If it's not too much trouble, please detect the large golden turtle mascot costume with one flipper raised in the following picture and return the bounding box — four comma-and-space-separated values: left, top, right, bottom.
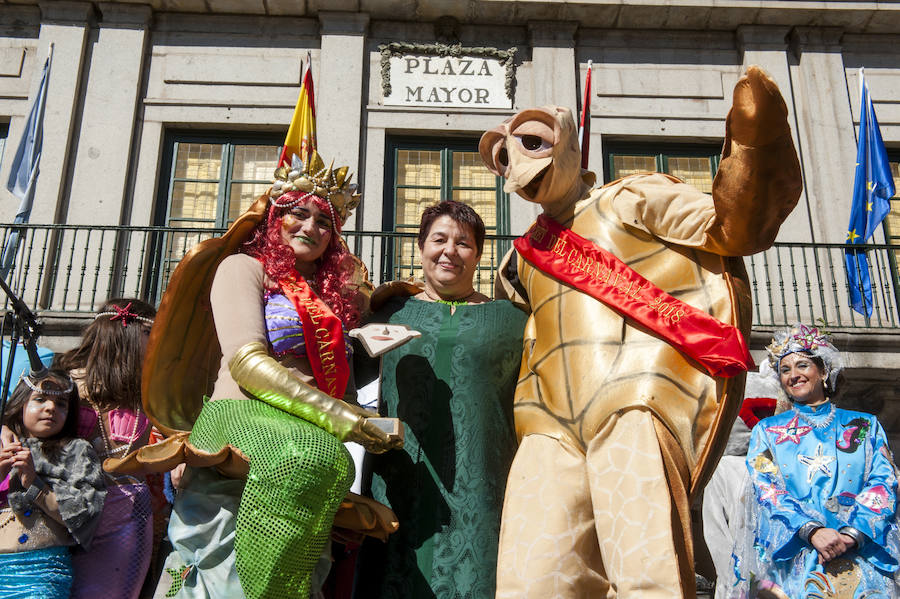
480, 67, 801, 599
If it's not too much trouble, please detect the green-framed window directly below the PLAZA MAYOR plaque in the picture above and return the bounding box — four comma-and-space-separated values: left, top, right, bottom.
385, 139, 509, 295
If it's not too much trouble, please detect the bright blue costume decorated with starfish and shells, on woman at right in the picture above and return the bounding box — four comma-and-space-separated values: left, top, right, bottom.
731, 402, 900, 599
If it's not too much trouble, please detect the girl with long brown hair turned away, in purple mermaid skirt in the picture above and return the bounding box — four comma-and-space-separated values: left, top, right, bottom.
56, 298, 156, 599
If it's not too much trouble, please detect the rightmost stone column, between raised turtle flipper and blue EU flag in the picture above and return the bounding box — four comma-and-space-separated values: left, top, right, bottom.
791, 27, 856, 243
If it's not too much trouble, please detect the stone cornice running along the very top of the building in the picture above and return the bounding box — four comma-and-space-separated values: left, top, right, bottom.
3, 0, 900, 33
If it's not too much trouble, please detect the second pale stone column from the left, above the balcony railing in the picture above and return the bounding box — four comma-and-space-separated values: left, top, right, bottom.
66, 2, 152, 225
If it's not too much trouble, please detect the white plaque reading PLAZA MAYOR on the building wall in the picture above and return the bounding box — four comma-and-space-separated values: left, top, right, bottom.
383, 55, 512, 108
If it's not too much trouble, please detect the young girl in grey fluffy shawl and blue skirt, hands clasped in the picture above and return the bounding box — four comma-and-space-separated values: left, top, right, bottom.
0, 370, 106, 599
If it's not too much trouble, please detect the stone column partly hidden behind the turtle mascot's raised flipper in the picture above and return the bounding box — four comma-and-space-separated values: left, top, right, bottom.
736, 25, 815, 241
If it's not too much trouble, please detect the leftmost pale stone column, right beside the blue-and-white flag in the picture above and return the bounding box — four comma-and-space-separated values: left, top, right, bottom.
30, 2, 93, 223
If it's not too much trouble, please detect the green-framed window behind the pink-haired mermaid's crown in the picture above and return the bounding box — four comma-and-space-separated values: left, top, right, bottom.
158, 133, 284, 288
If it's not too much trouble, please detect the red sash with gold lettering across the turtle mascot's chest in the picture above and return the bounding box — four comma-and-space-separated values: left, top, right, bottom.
515, 214, 755, 377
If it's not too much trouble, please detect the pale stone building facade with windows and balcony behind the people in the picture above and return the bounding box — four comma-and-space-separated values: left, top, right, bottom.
0, 0, 900, 432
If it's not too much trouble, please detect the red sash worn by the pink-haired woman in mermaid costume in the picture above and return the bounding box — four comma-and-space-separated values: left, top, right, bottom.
280, 273, 350, 399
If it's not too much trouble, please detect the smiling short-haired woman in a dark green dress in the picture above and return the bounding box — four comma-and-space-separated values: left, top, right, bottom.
355, 201, 526, 599
